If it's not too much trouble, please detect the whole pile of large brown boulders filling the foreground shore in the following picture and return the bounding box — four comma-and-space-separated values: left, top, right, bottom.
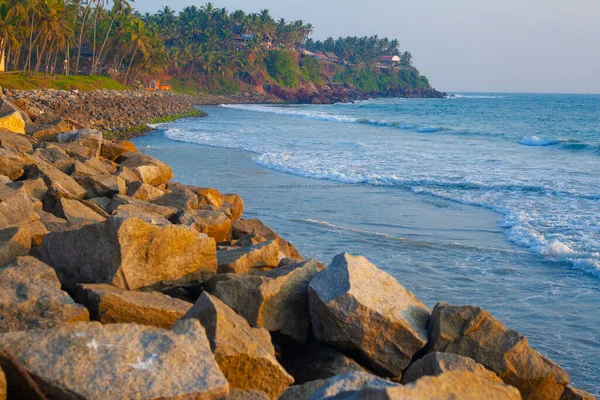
0, 97, 594, 400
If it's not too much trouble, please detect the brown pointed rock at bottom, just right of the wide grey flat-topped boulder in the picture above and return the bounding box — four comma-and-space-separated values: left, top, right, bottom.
183, 292, 294, 399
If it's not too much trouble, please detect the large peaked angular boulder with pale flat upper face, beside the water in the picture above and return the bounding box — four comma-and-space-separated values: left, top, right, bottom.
308, 253, 429, 378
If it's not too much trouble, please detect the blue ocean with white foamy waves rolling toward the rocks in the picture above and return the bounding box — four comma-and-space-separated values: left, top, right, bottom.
136, 93, 600, 395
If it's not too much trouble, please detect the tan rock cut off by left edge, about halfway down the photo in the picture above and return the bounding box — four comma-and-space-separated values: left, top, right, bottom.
0, 186, 40, 229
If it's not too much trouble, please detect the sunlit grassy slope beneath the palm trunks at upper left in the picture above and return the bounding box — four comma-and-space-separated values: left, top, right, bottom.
0, 72, 125, 92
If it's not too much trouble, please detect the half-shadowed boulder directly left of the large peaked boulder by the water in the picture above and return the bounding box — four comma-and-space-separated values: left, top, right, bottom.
207, 260, 325, 343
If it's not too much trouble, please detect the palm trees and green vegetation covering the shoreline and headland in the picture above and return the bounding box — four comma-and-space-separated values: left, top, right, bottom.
0, 0, 428, 94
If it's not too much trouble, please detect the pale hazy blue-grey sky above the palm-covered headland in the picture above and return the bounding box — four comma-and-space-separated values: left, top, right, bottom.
135, 0, 600, 93
